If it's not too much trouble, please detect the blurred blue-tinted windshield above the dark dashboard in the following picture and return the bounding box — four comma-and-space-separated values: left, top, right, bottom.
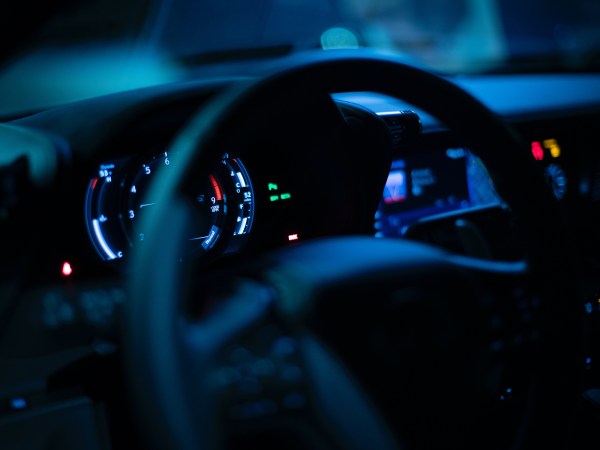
0, 0, 600, 115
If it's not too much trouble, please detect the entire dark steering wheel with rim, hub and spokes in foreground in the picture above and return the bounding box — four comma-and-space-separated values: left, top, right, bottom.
123, 51, 580, 449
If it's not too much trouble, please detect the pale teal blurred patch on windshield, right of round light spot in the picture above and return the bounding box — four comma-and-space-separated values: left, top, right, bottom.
341, 0, 507, 72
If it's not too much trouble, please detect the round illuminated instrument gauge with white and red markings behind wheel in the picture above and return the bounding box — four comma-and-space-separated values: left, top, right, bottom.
87, 152, 254, 260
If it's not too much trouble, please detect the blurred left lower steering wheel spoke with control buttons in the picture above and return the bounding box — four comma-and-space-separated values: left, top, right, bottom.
171, 279, 396, 450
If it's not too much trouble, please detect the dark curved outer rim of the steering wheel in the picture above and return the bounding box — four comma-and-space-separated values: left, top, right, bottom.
124, 51, 576, 448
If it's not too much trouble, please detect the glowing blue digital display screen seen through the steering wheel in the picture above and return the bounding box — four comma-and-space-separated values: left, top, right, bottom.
375, 148, 497, 236
